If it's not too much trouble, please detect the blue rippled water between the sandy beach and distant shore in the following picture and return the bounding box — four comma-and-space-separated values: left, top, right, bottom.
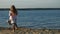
0, 10, 60, 29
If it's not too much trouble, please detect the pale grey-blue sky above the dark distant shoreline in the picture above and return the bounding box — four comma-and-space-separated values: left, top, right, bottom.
0, 0, 60, 8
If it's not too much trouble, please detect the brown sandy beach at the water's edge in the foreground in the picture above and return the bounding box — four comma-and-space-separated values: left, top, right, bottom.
0, 27, 60, 34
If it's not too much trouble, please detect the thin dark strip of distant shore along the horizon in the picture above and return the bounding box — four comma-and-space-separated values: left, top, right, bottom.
0, 8, 60, 10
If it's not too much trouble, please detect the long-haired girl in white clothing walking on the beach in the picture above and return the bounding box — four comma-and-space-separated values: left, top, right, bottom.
8, 5, 17, 32
